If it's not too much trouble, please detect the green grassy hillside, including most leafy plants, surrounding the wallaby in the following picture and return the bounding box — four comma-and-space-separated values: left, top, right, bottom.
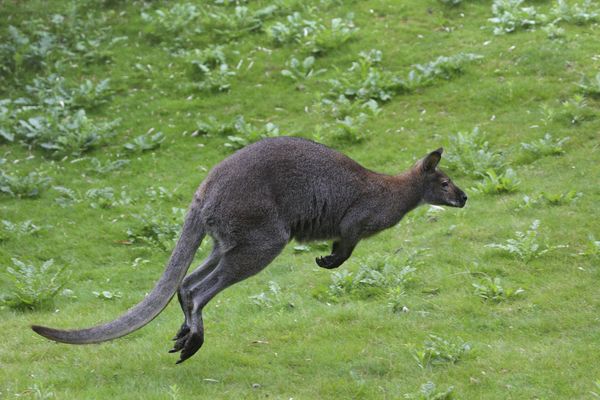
0, 0, 600, 399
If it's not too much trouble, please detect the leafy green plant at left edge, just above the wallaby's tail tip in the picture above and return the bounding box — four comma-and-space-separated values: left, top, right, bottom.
1, 258, 65, 310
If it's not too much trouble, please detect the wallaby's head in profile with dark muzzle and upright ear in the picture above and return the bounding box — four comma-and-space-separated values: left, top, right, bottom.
413, 147, 467, 208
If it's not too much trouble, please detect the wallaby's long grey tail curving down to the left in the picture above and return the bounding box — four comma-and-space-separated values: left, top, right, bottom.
31, 204, 206, 344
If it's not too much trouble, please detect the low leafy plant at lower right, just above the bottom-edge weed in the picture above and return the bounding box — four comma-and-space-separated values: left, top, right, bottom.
411, 335, 471, 369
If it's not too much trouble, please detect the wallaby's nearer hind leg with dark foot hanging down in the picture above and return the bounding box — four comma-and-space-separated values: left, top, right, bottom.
171, 237, 289, 363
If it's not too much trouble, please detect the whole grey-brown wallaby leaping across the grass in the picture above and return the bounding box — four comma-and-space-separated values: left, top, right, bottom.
32, 137, 467, 364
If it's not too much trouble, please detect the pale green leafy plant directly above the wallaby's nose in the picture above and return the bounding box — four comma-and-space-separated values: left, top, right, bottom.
444, 127, 504, 177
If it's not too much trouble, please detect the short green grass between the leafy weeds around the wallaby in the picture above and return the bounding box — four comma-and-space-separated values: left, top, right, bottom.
0, 0, 600, 399
